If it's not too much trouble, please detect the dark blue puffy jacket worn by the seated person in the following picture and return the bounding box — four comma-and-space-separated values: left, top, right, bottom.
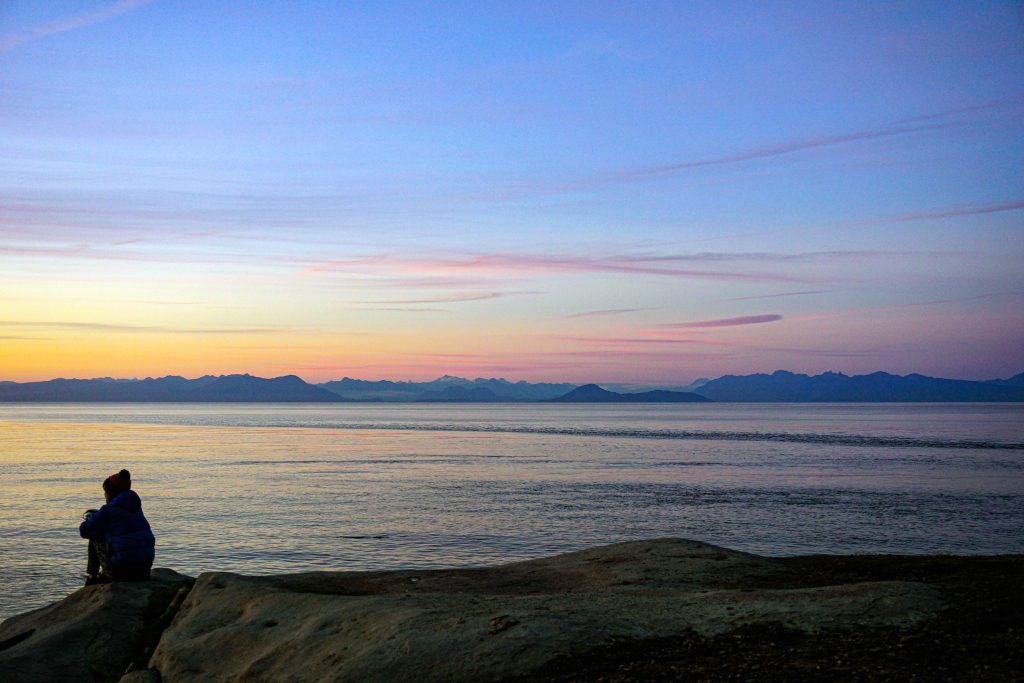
78, 490, 157, 565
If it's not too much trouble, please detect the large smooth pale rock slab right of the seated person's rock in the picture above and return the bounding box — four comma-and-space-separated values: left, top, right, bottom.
150, 539, 941, 683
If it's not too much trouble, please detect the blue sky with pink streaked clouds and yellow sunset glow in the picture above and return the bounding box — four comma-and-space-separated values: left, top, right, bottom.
0, 0, 1024, 386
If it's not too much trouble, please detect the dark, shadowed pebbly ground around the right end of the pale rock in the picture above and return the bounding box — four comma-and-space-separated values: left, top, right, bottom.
509, 555, 1024, 683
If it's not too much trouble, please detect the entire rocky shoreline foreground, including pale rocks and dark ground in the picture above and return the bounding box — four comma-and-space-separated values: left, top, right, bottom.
0, 539, 1024, 683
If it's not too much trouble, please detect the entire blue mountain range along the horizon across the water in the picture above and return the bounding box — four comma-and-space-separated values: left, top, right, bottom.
0, 371, 1024, 403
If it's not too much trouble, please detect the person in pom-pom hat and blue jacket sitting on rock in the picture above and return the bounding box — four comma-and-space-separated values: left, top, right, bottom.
78, 470, 157, 586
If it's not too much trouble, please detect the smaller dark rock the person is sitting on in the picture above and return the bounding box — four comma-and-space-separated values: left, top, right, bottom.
0, 569, 193, 683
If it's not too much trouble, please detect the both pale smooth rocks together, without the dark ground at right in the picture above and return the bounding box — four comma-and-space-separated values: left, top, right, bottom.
0, 539, 944, 683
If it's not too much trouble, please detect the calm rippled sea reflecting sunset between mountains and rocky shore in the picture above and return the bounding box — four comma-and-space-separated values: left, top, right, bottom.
0, 403, 1024, 618
